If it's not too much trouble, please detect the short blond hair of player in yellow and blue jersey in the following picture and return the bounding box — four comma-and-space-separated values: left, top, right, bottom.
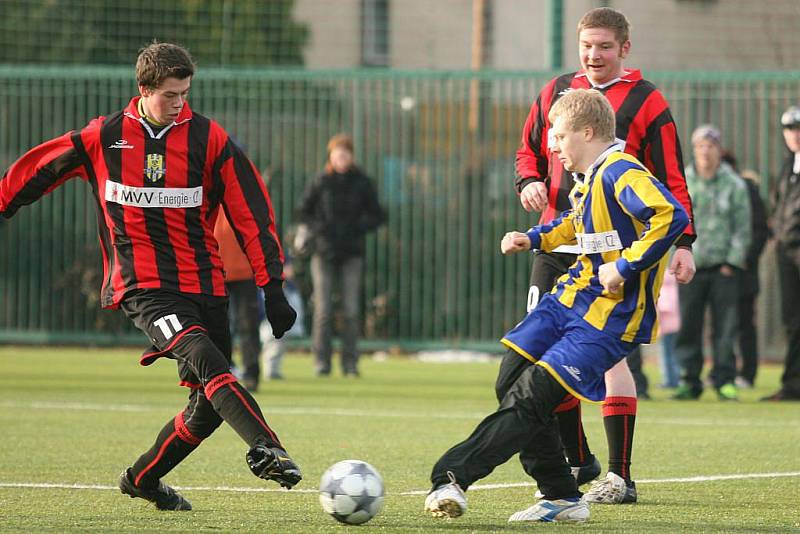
547, 89, 616, 141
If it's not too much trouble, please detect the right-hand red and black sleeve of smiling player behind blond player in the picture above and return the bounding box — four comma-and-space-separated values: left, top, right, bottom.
642, 91, 696, 245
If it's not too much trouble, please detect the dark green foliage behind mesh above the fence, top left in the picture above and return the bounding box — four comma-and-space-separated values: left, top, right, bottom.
0, 0, 308, 67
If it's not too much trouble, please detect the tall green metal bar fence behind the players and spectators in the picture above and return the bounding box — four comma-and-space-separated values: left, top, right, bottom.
0, 66, 800, 347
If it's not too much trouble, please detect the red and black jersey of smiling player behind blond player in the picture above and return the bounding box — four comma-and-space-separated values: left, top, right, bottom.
515, 70, 695, 245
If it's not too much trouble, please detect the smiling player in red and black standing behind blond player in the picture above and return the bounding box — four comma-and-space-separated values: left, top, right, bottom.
507, 8, 695, 502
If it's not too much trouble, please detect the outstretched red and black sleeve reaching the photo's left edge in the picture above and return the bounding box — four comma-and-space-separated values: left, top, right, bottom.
0, 132, 86, 217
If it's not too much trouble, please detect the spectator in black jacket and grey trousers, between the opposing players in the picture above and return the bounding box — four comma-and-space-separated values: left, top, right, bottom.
299, 134, 386, 376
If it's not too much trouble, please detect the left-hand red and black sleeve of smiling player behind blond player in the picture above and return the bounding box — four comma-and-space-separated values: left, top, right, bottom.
514, 79, 556, 193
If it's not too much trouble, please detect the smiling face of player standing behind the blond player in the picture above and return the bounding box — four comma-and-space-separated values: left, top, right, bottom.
578, 28, 631, 85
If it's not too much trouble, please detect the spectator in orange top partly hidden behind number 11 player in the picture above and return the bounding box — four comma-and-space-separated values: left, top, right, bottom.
214, 214, 260, 392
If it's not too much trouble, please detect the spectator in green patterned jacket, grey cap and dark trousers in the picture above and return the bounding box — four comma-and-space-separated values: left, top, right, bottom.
673, 125, 751, 400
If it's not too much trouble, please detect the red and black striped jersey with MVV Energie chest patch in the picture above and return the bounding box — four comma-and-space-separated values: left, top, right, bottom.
0, 97, 283, 308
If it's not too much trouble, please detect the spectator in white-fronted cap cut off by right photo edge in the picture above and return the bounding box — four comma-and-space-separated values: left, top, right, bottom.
762, 106, 800, 401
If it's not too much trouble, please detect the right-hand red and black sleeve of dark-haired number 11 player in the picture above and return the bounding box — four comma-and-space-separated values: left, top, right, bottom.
211, 127, 284, 286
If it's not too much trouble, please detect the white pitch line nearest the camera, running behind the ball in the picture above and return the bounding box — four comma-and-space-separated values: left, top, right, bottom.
0, 471, 800, 495
